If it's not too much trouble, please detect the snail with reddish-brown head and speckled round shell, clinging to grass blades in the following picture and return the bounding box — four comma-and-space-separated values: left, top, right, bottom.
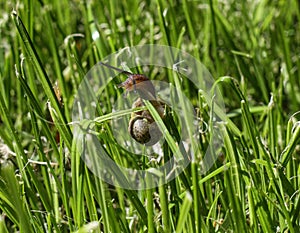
100, 62, 165, 146
